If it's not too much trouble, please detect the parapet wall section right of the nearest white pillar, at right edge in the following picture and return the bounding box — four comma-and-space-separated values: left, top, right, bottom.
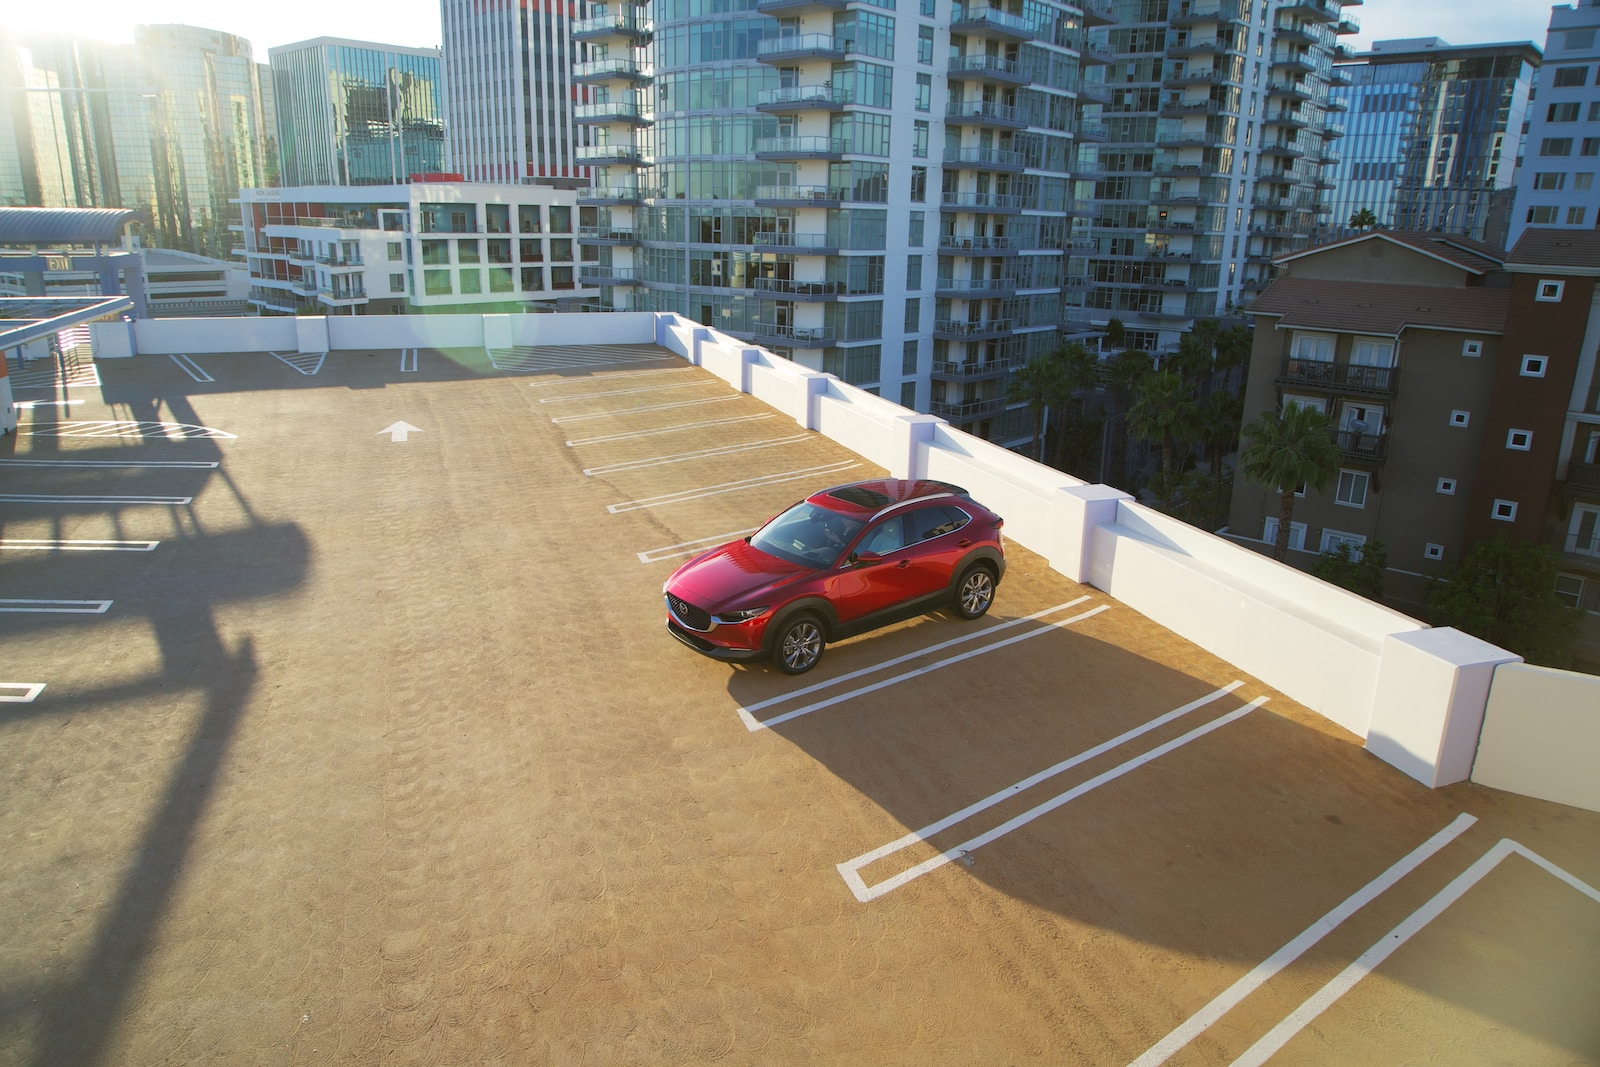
1472, 664, 1600, 811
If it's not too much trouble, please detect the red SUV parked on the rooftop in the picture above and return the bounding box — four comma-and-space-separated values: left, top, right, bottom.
662, 480, 1005, 675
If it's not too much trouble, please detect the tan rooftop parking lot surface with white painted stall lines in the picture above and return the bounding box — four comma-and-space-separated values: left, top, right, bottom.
9, 346, 1600, 1065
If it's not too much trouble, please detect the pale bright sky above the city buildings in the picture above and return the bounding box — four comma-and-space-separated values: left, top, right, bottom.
3, 0, 1550, 61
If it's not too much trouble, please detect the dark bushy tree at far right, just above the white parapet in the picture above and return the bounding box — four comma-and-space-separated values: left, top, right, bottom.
1427, 534, 1582, 667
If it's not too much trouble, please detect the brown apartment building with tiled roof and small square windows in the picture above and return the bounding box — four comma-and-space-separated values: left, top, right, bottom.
1229, 229, 1600, 661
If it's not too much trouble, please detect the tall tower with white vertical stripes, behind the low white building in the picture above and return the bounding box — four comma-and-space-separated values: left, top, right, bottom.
438, 0, 587, 187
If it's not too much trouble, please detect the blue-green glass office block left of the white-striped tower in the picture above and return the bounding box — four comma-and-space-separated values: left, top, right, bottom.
267, 37, 445, 186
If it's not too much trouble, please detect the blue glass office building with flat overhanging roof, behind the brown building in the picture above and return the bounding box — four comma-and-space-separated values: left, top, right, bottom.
1328, 37, 1539, 246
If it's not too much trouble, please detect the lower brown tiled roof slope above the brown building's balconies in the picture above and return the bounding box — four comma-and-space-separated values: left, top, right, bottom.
1245, 277, 1510, 338
